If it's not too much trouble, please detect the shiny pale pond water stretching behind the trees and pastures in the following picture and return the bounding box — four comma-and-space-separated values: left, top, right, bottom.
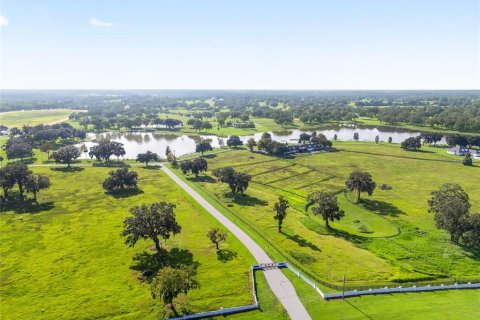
78, 126, 436, 159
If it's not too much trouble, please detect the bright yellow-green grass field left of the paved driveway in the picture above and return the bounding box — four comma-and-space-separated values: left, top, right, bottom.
0, 167, 282, 319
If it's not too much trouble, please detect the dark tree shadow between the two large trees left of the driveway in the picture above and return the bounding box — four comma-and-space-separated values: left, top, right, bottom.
130, 248, 200, 282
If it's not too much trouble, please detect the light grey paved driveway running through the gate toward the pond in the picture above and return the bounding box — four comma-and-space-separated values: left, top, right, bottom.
161, 165, 311, 320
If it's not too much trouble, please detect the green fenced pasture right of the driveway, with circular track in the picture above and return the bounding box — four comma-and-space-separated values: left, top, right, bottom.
174, 142, 480, 287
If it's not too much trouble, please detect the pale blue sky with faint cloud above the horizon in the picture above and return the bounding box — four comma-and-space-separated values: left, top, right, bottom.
0, 0, 480, 89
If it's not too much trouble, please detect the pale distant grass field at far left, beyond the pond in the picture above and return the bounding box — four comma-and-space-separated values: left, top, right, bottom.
0, 109, 80, 128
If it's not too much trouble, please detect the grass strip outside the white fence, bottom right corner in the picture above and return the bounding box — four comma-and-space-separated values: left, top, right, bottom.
284, 269, 480, 320
